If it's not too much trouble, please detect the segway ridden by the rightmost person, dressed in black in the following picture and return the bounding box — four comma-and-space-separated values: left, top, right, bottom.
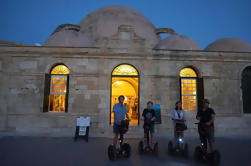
194, 123, 221, 166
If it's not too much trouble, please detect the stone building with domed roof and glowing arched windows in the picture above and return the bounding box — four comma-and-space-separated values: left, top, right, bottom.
0, 6, 251, 137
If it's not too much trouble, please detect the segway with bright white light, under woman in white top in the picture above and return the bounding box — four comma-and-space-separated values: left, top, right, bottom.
168, 123, 188, 157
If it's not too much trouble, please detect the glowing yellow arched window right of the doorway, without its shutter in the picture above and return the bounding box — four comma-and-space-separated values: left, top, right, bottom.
180, 68, 197, 111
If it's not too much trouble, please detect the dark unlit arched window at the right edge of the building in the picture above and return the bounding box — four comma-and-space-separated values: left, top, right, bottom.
241, 66, 251, 113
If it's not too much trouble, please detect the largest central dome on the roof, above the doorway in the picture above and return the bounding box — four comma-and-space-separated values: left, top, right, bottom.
80, 6, 159, 48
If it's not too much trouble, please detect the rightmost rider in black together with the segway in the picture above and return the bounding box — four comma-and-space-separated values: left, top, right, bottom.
194, 99, 220, 166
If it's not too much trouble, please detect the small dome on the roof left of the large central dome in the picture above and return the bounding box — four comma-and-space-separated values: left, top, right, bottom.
44, 29, 93, 47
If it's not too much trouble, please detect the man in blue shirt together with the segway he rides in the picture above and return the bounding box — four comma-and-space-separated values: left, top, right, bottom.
108, 95, 131, 160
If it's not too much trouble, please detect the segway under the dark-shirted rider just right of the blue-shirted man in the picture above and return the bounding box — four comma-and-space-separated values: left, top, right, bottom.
138, 120, 158, 156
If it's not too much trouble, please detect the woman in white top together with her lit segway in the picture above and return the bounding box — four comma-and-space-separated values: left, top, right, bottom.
168, 101, 188, 157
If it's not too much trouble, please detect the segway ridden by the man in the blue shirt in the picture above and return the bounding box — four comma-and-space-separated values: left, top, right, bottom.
108, 120, 131, 160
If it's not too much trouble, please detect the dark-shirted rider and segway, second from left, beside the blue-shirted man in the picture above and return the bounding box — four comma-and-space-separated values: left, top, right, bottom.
138, 101, 158, 156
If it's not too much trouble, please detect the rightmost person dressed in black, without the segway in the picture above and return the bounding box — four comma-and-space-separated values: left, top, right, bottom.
196, 99, 215, 153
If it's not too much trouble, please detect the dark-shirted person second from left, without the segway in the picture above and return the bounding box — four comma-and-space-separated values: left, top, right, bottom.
142, 101, 156, 144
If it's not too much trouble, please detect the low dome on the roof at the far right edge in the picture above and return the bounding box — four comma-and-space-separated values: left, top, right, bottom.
205, 38, 251, 52
